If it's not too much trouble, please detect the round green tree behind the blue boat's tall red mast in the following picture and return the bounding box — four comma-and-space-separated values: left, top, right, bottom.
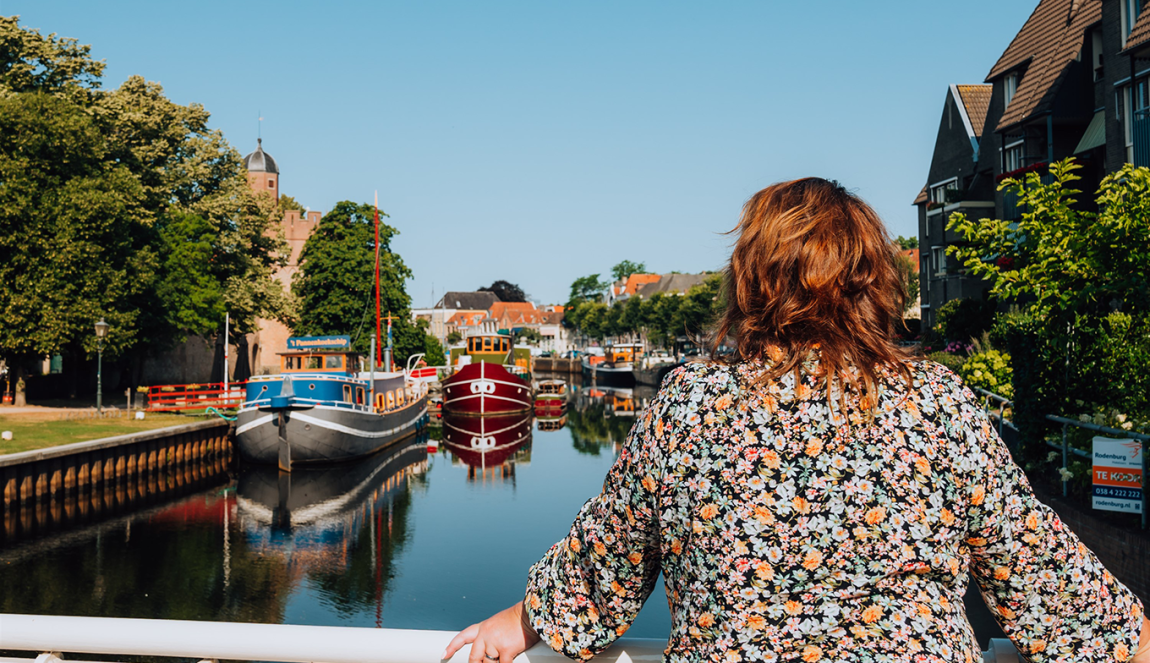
292, 200, 432, 365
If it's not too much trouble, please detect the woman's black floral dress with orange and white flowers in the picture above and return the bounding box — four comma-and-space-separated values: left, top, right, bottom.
524, 357, 1142, 663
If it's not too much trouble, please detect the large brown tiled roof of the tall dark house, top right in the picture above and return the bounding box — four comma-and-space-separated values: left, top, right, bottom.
987, 0, 1102, 130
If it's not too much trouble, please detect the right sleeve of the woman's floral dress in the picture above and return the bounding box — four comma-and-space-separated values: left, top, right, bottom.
941, 376, 1143, 663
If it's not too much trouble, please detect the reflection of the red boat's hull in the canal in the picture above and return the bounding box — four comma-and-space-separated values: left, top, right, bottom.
443, 413, 531, 481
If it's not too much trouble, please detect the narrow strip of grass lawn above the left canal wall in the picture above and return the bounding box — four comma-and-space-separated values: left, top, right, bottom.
0, 413, 202, 454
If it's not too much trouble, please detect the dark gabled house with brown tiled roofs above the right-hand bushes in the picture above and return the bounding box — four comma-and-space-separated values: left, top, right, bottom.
914, 0, 1150, 325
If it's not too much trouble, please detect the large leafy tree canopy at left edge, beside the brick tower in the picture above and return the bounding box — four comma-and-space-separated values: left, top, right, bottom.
0, 17, 288, 372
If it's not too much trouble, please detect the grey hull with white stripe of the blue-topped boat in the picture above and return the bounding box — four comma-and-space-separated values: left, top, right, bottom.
236, 396, 428, 464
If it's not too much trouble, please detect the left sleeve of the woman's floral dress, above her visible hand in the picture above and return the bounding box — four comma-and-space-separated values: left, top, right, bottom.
523, 373, 679, 661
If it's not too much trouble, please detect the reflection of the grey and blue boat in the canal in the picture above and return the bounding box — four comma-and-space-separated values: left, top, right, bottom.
236, 435, 428, 571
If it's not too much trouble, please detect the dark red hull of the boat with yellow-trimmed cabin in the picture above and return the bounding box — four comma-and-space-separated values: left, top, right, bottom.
443, 362, 534, 415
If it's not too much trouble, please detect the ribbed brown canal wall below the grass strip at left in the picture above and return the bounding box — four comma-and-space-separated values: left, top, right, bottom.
0, 419, 233, 510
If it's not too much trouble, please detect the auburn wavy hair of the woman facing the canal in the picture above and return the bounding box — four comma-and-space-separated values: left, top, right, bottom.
711, 177, 911, 409
